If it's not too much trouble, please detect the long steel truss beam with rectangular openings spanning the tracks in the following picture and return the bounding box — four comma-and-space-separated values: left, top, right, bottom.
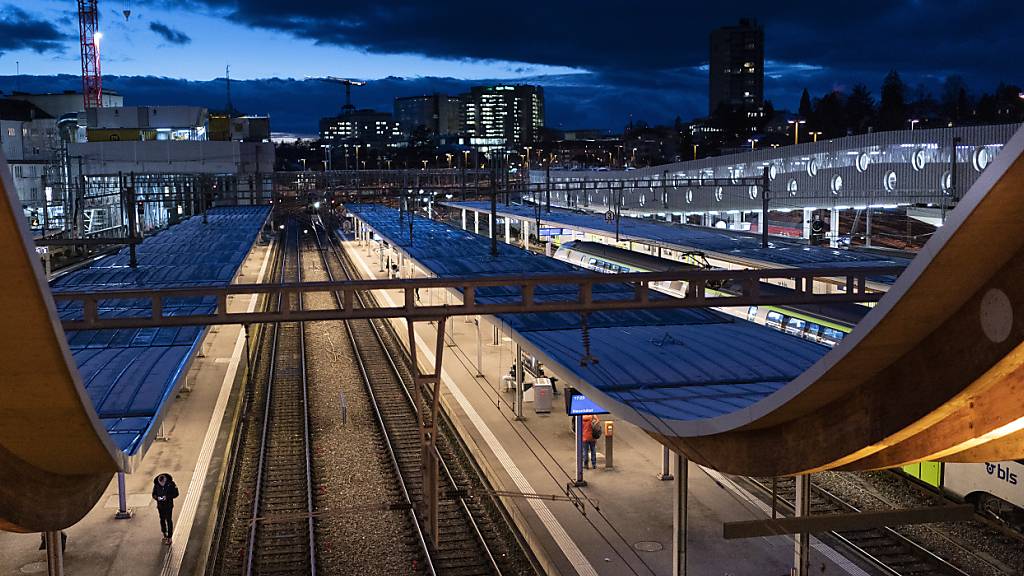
53, 266, 902, 330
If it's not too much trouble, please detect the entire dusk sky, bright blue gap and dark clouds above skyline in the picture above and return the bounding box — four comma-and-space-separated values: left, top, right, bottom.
0, 0, 1024, 133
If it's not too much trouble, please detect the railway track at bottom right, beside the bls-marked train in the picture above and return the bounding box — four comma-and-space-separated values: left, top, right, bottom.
748, 478, 970, 576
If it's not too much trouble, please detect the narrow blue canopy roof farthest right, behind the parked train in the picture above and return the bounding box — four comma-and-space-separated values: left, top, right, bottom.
444, 202, 910, 284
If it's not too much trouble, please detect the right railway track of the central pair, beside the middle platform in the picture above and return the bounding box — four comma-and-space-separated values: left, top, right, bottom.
316, 217, 538, 576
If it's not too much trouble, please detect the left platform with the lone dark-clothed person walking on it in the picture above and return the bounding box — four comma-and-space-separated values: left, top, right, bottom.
0, 226, 271, 576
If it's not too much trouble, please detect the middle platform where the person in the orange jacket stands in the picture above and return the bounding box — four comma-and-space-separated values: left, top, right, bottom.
343, 211, 865, 576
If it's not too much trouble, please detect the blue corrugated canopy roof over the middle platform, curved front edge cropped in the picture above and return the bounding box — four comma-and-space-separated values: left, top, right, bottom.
348, 205, 828, 420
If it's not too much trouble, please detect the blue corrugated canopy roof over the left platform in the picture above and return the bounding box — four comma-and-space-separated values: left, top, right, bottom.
52, 206, 269, 455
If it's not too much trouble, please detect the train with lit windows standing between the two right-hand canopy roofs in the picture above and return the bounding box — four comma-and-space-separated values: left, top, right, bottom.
555, 241, 868, 346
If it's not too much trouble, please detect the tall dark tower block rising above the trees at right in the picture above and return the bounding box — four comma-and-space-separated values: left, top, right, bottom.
708, 18, 765, 115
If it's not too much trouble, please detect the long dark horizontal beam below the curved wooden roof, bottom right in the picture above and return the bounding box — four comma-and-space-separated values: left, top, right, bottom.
722, 504, 974, 540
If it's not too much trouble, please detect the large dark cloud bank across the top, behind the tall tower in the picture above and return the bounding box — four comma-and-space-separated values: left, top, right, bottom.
142, 0, 1024, 81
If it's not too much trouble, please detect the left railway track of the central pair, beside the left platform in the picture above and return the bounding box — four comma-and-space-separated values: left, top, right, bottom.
210, 220, 316, 576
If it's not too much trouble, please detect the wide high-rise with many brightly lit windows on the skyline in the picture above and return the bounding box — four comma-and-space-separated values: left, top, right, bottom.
460, 84, 544, 147
